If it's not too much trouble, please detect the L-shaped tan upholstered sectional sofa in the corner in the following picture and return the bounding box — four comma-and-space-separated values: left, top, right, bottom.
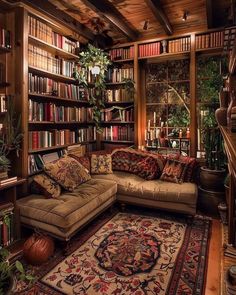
17, 149, 197, 240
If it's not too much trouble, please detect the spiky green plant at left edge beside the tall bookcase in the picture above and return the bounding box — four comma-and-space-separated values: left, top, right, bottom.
0, 96, 23, 179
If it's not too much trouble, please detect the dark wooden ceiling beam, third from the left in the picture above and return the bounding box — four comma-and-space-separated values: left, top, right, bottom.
145, 0, 173, 35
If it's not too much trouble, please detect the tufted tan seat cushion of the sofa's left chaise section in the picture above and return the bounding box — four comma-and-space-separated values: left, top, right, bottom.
17, 179, 117, 230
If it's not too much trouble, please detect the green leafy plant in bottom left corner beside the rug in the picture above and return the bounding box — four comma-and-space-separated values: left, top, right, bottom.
0, 248, 35, 294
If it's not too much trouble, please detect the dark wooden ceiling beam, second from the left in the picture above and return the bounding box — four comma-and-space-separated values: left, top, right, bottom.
82, 0, 139, 41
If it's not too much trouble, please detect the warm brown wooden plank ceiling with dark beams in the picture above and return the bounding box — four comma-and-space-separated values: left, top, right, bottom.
20, 0, 235, 46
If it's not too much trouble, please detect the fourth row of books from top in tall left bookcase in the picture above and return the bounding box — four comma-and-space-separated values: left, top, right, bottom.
29, 99, 93, 122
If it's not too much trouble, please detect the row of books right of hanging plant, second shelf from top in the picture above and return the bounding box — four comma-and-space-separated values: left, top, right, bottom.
106, 67, 134, 83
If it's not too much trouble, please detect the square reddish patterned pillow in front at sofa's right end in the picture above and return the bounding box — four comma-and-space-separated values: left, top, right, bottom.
160, 159, 187, 183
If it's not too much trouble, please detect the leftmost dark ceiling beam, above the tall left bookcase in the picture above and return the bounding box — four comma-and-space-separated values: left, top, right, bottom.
20, 0, 95, 40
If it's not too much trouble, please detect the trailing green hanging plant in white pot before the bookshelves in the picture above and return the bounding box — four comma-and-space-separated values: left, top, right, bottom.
73, 44, 111, 133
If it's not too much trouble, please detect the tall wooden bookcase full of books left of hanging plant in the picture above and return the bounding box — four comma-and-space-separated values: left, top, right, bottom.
11, 7, 96, 177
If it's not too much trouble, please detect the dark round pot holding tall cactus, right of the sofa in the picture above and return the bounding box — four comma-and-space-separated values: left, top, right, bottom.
200, 167, 226, 192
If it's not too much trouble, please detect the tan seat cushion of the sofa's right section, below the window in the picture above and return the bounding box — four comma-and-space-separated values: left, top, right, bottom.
93, 172, 197, 205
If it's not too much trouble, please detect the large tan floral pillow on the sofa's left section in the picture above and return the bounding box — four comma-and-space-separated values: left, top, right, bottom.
44, 156, 91, 192
